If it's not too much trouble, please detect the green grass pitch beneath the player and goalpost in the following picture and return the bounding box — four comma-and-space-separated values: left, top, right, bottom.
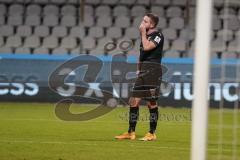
0, 103, 240, 160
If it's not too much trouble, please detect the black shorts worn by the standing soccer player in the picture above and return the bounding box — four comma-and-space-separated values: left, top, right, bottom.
131, 62, 162, 100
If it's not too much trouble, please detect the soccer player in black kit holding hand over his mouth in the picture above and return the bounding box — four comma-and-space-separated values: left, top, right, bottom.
115, 13, 164, 141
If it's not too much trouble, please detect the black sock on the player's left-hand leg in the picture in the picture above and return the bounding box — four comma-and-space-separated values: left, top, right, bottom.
128, 107, 139, 133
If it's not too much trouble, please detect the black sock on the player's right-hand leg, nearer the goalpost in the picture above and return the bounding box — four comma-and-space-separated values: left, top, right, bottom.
149, 107, 158, 134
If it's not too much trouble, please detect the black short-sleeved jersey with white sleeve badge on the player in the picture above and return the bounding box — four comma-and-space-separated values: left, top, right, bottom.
139, 31, 164, 63
